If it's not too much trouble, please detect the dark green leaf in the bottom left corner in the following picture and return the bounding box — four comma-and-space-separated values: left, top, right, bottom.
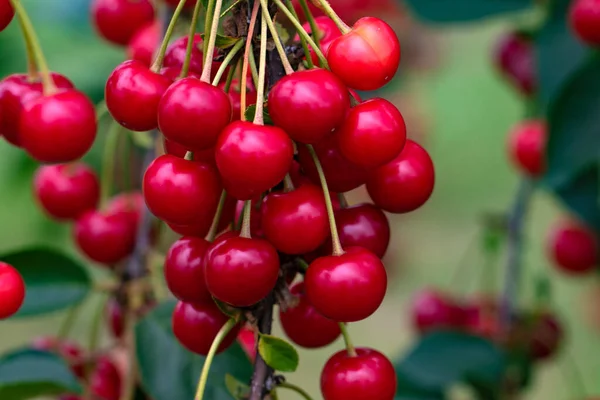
0, 349, 81, 400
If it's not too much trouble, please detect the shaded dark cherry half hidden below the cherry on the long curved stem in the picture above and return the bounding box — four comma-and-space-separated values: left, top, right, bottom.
279, 282, 342, 349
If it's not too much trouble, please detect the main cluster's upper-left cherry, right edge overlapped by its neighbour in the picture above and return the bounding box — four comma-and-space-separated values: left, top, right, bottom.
105, 60, 171, 132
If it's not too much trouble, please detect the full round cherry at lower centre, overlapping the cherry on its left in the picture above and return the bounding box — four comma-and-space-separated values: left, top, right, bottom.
204, 237, 279, 307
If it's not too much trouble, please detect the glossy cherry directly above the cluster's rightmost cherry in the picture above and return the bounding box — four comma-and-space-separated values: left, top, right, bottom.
336, 98, 406, 168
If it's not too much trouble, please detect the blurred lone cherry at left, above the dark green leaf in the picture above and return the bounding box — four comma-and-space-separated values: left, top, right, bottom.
33, 163, 100, 220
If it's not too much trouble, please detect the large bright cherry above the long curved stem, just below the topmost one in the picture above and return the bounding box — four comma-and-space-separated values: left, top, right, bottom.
269, 68, 350, 143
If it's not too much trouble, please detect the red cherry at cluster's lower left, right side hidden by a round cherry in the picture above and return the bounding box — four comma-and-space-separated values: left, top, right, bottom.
164, 237, 212, 303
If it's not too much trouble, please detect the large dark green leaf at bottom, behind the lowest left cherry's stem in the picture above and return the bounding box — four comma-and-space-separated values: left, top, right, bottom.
135, 301, 252, 400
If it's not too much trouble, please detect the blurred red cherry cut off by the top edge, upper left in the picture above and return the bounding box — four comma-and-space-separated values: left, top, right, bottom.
91, 0, 154, 46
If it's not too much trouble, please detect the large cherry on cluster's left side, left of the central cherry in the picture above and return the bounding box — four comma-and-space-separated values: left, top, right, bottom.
143, 154, 222, 227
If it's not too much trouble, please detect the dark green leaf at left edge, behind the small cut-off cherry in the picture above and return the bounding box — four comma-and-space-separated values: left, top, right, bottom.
0, 248, 92, 317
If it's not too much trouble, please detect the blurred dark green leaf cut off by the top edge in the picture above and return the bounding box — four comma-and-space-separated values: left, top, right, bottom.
406, 0, 534, 23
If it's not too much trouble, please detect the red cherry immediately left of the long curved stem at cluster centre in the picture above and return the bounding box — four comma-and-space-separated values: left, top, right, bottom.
262, 184, 329, 254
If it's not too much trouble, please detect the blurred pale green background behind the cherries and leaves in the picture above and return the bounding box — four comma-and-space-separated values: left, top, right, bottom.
0, 0, 600, 400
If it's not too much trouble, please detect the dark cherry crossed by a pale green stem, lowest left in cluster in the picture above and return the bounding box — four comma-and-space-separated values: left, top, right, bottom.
172, 301, 240, 356
